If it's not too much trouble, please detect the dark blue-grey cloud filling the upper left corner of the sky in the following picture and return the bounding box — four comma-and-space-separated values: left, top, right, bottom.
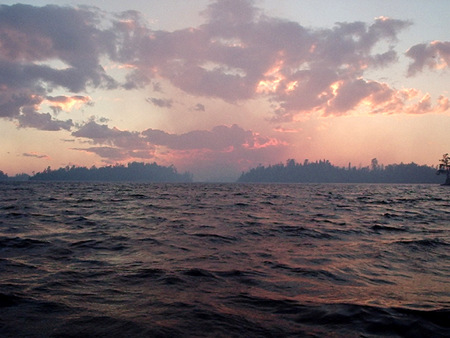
0, 4, 118, 92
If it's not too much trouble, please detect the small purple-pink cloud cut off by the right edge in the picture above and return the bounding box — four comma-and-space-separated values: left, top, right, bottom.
406, 41, 450, 76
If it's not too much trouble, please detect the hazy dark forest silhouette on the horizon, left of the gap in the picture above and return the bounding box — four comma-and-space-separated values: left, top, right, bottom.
0, 162, 192, 182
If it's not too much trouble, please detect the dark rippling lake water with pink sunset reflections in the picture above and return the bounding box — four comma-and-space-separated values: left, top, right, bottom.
0, 182, 450, 337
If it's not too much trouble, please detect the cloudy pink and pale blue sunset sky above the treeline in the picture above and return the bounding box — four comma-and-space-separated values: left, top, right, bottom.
0, 0, 450, 181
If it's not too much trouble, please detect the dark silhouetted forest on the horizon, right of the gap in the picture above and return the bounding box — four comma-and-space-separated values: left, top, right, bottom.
238, 158, 442, 183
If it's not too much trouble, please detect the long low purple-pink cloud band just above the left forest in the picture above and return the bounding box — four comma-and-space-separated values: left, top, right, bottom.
72, 121, 287, 177
